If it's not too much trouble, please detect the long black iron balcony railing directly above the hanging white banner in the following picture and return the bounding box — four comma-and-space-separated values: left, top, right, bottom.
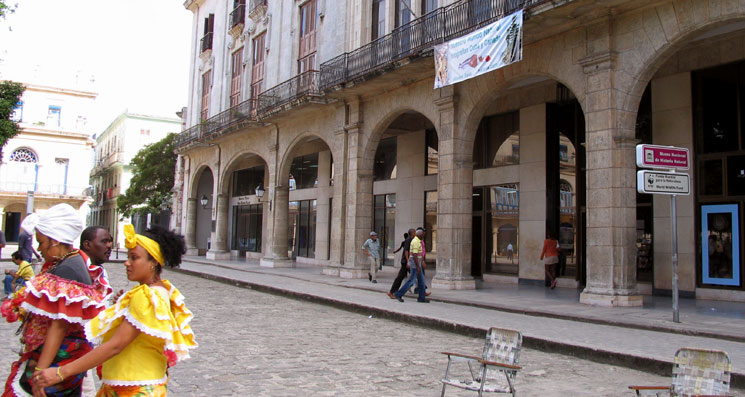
320, 0, 550, 91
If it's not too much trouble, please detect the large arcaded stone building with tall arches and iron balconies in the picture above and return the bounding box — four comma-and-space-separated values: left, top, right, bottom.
175, 0, 745, 306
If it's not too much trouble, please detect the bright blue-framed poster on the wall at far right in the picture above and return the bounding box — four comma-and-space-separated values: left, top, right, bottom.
701, 204, 740, 286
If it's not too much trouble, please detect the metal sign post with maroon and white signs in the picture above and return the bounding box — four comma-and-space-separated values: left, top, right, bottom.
636, 145, 691, 323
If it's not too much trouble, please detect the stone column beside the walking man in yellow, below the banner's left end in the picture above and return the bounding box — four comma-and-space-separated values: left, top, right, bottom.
432, 86, 476, 289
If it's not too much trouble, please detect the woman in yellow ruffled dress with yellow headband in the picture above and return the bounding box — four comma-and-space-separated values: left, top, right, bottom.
34, 225, 197, 397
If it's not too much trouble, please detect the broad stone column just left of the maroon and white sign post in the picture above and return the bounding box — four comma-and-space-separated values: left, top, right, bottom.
580, 45, 642, 306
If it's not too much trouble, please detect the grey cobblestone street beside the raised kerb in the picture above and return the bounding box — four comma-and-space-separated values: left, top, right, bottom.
0, 264, 720, 396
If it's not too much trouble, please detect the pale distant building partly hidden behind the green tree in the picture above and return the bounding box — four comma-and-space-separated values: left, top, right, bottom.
88, 112, 181, 247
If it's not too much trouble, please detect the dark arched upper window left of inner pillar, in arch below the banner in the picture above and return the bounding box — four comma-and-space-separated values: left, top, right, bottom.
473, 112, 520, 169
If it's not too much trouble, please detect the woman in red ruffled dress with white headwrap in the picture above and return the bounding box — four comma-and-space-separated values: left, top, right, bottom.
2, 204, 113, 397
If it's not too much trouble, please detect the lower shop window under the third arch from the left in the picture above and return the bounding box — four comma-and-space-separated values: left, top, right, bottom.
287, 200, 316, 258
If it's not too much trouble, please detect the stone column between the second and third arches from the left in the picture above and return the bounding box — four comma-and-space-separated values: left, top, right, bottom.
260, 186, 295, 267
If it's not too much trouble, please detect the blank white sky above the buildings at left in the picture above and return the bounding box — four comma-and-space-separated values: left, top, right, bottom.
0, 0, 192, 135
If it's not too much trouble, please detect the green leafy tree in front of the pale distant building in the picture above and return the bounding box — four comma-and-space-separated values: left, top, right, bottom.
116, 133, 176, 217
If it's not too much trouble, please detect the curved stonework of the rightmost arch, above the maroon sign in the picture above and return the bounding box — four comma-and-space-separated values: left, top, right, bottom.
618, 8, 745, 119
